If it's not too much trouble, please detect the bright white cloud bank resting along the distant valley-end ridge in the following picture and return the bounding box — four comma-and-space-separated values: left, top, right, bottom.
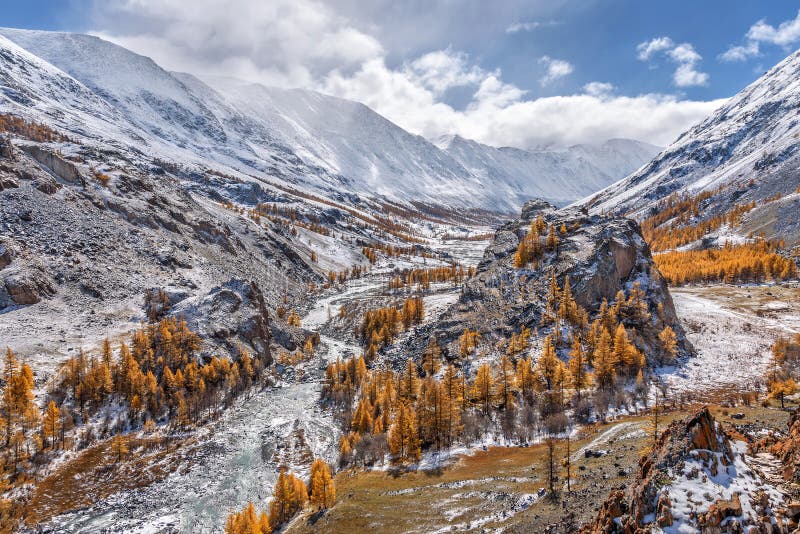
325, 56, 722, 148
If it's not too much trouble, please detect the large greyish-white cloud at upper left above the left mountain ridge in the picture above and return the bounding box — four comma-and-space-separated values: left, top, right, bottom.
95, 0, 385, 86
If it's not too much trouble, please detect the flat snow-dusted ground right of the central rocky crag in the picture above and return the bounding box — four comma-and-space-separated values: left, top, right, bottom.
660, 286, 800, 393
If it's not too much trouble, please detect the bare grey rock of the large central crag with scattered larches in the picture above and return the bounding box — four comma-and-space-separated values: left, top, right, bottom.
404, 201, 692, 364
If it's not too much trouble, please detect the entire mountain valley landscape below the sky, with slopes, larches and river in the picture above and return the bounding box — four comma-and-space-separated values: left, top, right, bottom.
0, 23, 800, 534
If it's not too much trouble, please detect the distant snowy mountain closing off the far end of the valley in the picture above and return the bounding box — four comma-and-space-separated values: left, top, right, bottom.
437, 136, 659, 204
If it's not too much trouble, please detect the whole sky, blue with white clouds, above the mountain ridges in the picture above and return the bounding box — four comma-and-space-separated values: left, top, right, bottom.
0, 0, 800, 148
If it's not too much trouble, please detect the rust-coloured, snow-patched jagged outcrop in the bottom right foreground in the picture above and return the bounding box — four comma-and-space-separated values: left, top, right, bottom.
583, 408, 791, 534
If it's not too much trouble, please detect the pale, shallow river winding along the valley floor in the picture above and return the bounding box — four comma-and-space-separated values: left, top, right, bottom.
23, 242, 486, 533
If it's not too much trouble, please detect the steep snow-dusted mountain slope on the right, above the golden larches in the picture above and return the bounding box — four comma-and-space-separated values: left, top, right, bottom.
583, 47, 800, 236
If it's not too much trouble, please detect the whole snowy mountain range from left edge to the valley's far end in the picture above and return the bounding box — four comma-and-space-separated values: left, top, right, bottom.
0, 29, 657, 212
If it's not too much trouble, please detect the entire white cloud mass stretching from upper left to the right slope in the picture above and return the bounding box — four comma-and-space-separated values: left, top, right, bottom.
90, 0, 719, 148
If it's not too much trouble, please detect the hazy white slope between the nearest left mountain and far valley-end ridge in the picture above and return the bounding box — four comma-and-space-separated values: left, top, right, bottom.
200, 78, 488, 209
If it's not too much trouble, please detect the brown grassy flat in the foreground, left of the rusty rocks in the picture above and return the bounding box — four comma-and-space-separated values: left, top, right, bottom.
287, 404, 788, 533
